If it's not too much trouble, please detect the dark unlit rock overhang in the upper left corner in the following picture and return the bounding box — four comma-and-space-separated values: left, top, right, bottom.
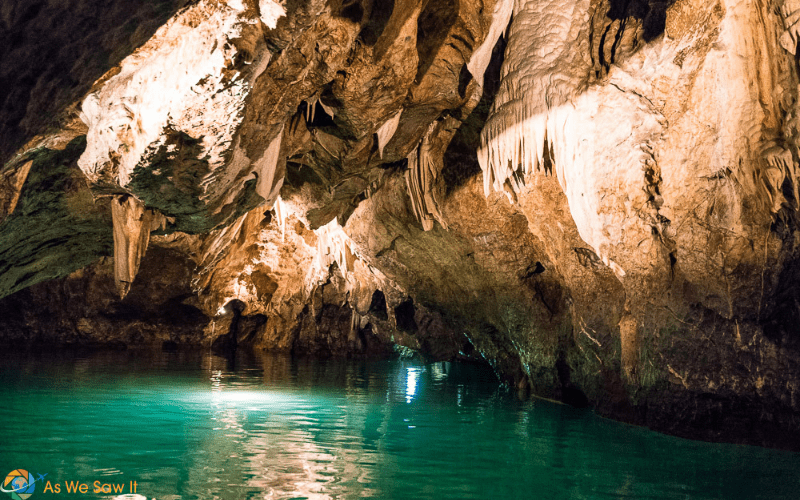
0, 0, 186, 167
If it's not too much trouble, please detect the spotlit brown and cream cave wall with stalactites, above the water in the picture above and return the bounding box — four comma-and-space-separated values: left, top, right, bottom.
0, 0, 800, 447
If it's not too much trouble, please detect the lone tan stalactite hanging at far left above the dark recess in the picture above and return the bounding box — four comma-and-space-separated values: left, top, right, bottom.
111, 195, 159, 298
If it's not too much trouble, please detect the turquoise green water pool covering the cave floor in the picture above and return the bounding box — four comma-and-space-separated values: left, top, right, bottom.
0, 351, 800, 500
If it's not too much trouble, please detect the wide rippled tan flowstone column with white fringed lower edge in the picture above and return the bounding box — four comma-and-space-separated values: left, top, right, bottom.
478, 0, 589, 200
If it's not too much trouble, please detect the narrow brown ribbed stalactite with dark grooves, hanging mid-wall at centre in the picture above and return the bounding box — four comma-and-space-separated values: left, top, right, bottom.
406, 122, 447, 231
